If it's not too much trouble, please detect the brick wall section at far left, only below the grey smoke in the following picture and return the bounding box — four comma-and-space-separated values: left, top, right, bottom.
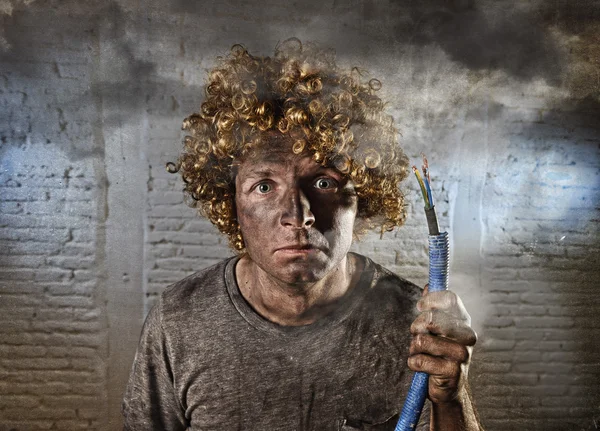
0, 149, 107, 430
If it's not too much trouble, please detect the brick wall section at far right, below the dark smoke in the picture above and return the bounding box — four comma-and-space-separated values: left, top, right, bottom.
474, 105, 600, 430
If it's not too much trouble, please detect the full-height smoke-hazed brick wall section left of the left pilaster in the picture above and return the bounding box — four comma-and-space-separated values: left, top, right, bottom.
0, 2, 108, 430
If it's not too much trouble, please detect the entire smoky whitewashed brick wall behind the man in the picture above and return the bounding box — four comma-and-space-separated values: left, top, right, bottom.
0, 0, 600, 430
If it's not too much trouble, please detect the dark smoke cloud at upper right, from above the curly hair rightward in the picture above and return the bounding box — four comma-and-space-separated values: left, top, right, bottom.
159, 0, 600, 138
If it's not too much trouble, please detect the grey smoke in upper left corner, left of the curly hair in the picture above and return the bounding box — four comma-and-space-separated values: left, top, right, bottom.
0, 0, 206, 160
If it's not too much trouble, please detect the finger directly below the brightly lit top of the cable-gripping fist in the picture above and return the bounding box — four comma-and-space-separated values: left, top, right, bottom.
410, 310, 477, 346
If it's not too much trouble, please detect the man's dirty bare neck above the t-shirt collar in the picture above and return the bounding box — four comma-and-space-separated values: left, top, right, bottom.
235, 255, 361, 326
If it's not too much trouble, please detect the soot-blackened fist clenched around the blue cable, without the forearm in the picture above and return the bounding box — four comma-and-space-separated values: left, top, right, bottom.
408, 286, 477, 403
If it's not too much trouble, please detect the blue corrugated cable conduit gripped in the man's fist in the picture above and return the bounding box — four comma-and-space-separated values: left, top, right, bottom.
395, 231, 450, 431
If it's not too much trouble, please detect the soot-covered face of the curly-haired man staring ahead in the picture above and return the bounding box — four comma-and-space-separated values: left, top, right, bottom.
235, 141, 357, 283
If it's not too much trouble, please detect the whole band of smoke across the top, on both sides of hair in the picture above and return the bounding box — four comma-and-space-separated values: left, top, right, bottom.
0, 0, 600, 142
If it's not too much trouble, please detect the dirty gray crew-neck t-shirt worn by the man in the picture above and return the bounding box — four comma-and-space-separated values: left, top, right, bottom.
123, 256, 429, 431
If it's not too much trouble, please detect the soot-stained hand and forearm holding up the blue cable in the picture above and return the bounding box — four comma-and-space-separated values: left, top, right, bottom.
408, 291, 483, 431
